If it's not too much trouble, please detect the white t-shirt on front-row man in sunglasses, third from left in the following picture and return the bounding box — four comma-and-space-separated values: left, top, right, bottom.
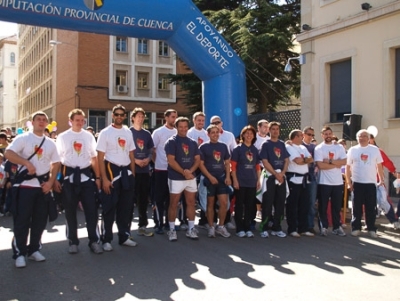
97, 125, 136, 166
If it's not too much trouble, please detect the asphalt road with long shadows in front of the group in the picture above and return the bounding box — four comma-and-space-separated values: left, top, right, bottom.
0, 212, 400, 301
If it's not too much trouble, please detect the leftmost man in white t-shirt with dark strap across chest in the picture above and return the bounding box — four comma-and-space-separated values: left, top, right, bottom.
5, 112, 60, 268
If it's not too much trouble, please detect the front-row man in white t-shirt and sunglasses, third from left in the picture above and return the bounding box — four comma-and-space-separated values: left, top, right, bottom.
97, 104, 137, 252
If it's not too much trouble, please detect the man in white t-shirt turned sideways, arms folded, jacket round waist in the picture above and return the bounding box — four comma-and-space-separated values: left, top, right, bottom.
286, 130, 314, 237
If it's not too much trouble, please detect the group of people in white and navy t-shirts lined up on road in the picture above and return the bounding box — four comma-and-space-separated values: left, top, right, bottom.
0, 104, 398, 268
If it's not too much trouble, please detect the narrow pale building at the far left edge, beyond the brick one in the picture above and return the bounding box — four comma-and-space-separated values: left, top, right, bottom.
0, 35, 18, 133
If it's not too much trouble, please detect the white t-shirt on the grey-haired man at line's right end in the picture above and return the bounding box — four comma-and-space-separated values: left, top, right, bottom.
347, 144, 383, 184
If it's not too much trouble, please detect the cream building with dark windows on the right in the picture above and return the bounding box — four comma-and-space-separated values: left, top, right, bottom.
297, 0, 400, 167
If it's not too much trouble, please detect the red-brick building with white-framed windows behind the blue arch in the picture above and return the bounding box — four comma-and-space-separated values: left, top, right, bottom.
19, 25, 187, 132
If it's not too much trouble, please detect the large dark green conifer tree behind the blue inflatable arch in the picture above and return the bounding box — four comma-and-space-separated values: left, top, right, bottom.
171, 0, 300, 113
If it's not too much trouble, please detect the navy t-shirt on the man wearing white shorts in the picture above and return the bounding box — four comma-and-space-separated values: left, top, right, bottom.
164, 135, 200, 181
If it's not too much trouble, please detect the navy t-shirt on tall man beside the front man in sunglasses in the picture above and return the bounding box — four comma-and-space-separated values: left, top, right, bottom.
130, 127, 154, 173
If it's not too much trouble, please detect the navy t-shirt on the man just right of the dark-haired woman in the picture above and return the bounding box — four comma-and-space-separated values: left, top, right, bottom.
260, 140, 290, 170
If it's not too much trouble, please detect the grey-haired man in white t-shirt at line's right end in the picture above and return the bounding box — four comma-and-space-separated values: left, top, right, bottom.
346, 129, 384, 238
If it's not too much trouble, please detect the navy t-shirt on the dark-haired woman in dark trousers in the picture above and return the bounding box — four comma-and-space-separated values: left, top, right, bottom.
231, 144, 261, 187
